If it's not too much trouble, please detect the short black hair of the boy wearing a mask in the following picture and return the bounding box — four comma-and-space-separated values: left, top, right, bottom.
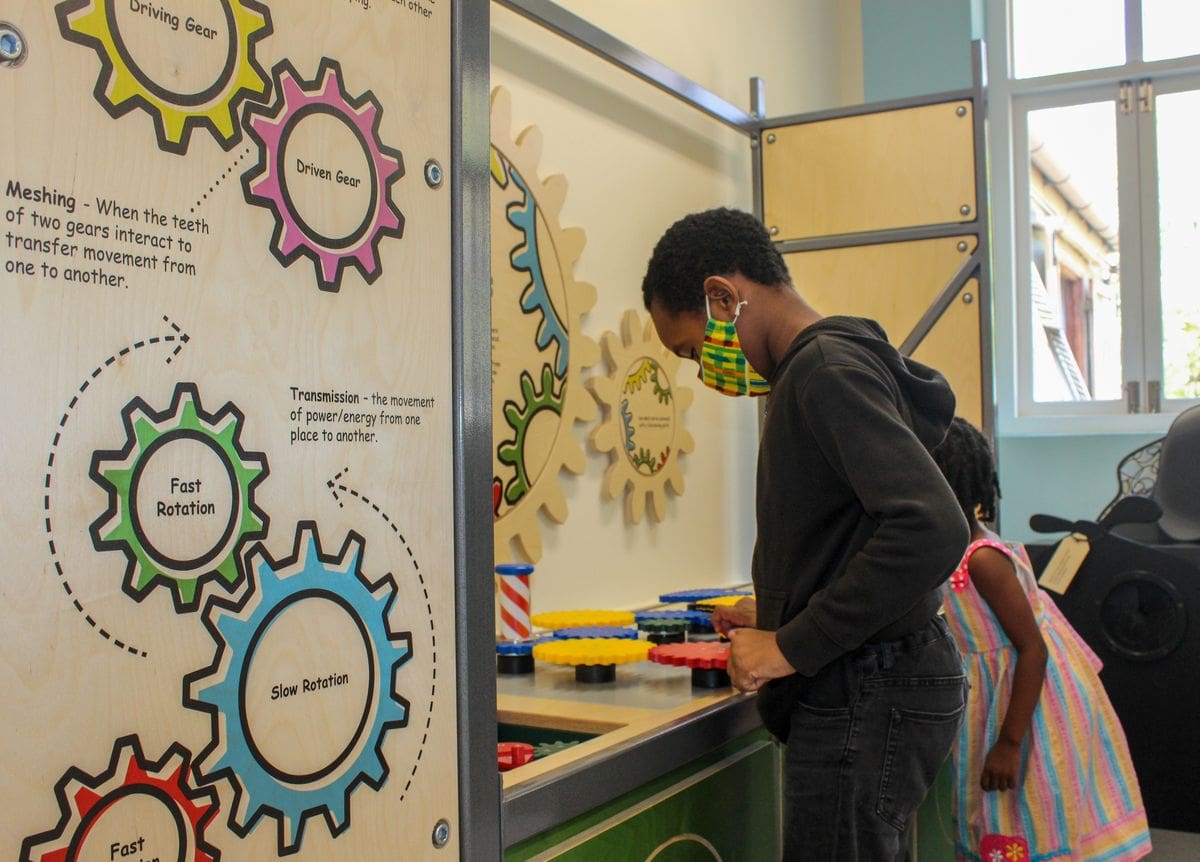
642, 206, 792, 313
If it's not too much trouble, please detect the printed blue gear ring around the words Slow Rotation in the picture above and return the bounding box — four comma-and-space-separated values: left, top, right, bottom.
184, 521, 413, 856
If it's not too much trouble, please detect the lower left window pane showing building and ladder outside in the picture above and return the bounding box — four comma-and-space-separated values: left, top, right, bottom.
1028, 101, 1122, 401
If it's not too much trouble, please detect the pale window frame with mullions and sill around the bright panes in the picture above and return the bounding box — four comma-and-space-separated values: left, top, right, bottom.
986, 0, 1200, 435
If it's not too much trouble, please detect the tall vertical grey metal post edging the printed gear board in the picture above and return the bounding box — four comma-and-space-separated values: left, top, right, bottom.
450, 0, 502, 860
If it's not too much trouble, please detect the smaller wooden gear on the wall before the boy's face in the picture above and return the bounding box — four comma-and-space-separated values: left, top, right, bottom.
588, 309, 696, 523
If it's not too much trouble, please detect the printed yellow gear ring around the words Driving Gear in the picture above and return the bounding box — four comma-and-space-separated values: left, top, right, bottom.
56, 0, 271, 154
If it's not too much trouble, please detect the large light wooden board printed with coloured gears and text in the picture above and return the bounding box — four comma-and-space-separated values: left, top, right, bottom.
0, 0, 458, 862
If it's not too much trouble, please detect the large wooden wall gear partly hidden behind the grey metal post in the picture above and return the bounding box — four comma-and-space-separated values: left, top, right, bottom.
491, 88, 600, 563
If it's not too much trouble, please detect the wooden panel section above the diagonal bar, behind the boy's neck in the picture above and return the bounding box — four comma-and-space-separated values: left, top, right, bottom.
784, 237, 976, 345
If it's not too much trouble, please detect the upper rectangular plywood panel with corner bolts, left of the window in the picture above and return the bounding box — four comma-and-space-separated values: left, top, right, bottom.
762, 101, 976, 241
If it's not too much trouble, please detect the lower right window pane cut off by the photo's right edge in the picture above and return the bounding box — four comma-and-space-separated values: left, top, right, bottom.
1154, 90, 1200, 399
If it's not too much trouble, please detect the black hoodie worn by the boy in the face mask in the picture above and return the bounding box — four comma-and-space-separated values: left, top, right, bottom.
754, 317, 970, 686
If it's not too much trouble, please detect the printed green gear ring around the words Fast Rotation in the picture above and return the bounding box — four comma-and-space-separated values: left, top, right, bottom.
90, 383, 268, 613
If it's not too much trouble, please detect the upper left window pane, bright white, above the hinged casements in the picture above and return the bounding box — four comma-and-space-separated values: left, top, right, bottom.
1012, 0, 1126, 78
